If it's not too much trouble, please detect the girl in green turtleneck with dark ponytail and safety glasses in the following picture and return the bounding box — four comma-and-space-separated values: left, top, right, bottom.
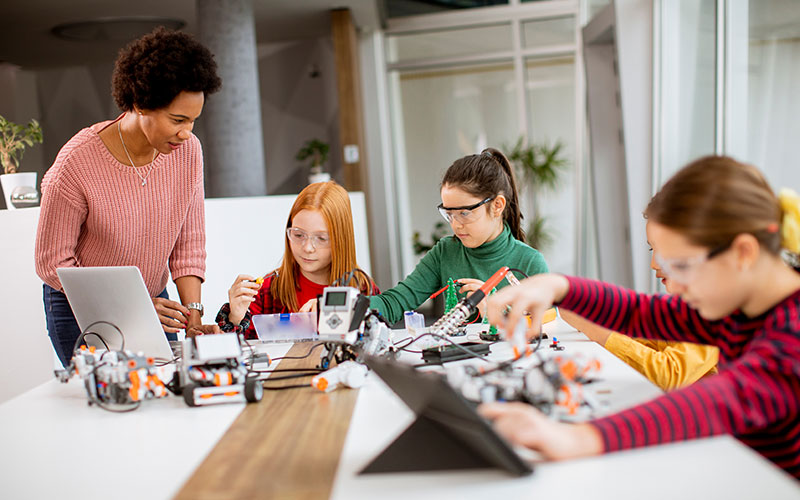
370, 148, 548, 323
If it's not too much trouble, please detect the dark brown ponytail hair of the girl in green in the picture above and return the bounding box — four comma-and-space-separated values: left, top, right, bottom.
440, 148, 525, 242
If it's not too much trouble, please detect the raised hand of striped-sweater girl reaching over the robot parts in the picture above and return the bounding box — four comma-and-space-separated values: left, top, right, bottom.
487, 274, 569, 339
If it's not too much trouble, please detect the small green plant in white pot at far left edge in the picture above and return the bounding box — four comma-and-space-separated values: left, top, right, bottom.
0, 116, 42, 210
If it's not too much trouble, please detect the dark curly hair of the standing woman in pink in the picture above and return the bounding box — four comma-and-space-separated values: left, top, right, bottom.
111, 27, 222, 111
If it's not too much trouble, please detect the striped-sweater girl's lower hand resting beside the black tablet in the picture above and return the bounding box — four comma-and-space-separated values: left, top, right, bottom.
478, 403, 603, 460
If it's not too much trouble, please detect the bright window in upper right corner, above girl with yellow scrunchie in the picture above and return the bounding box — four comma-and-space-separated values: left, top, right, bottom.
725, 0, 800, 190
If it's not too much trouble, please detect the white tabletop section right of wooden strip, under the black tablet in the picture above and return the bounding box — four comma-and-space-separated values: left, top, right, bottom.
332, 320, 800, 500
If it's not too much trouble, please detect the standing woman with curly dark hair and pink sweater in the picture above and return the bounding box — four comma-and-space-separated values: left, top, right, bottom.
35, 28, 222, 365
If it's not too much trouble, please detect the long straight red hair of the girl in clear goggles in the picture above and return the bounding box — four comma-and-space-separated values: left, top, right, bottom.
270, 181, 372, 311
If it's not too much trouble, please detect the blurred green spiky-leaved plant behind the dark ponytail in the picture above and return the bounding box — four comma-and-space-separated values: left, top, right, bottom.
503, 137, 568, 250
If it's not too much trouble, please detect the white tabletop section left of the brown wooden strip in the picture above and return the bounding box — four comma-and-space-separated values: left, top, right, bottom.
0, 344, 291, 500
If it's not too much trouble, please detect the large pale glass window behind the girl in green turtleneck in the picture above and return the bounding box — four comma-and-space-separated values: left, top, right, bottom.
386, 2, 584, 273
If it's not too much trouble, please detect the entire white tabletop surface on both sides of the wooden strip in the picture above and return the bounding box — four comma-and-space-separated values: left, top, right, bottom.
0, 325, 800, 500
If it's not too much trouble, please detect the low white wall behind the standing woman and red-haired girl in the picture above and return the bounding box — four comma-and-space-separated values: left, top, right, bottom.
0, 193, 372, 403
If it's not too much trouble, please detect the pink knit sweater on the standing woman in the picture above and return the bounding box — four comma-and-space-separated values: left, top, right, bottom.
36, 118, 206, 296
